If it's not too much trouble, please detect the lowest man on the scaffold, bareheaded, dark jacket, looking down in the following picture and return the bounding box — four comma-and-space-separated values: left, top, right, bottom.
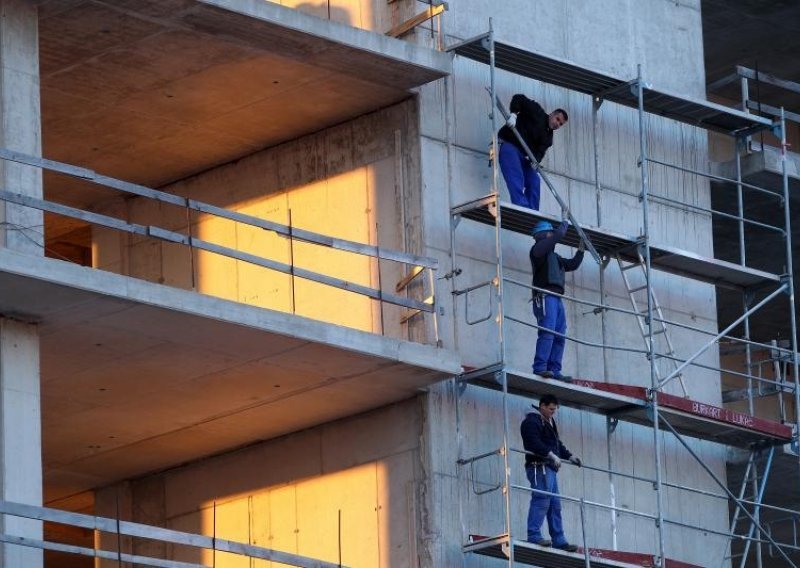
520, 394, 583, 552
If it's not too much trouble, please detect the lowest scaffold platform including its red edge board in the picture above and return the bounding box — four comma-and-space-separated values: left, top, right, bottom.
464, 535, 700, 568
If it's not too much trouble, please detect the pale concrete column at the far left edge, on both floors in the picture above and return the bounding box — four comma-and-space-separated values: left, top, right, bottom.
0, 0, 44, 568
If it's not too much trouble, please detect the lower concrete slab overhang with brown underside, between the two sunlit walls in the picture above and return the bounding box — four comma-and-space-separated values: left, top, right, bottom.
0, 249, 461, 500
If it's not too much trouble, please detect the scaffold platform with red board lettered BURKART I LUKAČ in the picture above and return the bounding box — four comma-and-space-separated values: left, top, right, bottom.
461, 368, 792, 448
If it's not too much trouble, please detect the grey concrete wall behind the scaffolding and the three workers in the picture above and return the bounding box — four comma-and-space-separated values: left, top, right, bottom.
420, 0, 727, 566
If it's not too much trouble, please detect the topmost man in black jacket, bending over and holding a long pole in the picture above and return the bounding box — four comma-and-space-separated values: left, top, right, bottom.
497, 95, 569, 210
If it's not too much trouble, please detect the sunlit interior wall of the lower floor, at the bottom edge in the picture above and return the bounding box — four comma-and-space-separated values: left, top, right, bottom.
96, 399, 424, 568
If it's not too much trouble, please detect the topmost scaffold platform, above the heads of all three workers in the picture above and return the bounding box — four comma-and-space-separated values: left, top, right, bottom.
449, 34, 772, 134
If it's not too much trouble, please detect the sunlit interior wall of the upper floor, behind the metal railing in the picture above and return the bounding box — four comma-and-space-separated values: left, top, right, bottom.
93, 100, 419, 336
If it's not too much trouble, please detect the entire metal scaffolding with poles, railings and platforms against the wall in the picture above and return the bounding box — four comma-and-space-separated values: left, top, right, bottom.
449, 21, 800, 568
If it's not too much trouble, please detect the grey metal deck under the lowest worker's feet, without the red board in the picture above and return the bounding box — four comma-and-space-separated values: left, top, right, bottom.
463, 536, 642, 568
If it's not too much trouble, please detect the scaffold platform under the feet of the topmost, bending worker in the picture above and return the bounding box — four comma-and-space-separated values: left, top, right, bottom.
452, 194, 780, 290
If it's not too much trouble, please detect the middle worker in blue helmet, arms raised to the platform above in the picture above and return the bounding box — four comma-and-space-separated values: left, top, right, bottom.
530, 217, 584, 382
